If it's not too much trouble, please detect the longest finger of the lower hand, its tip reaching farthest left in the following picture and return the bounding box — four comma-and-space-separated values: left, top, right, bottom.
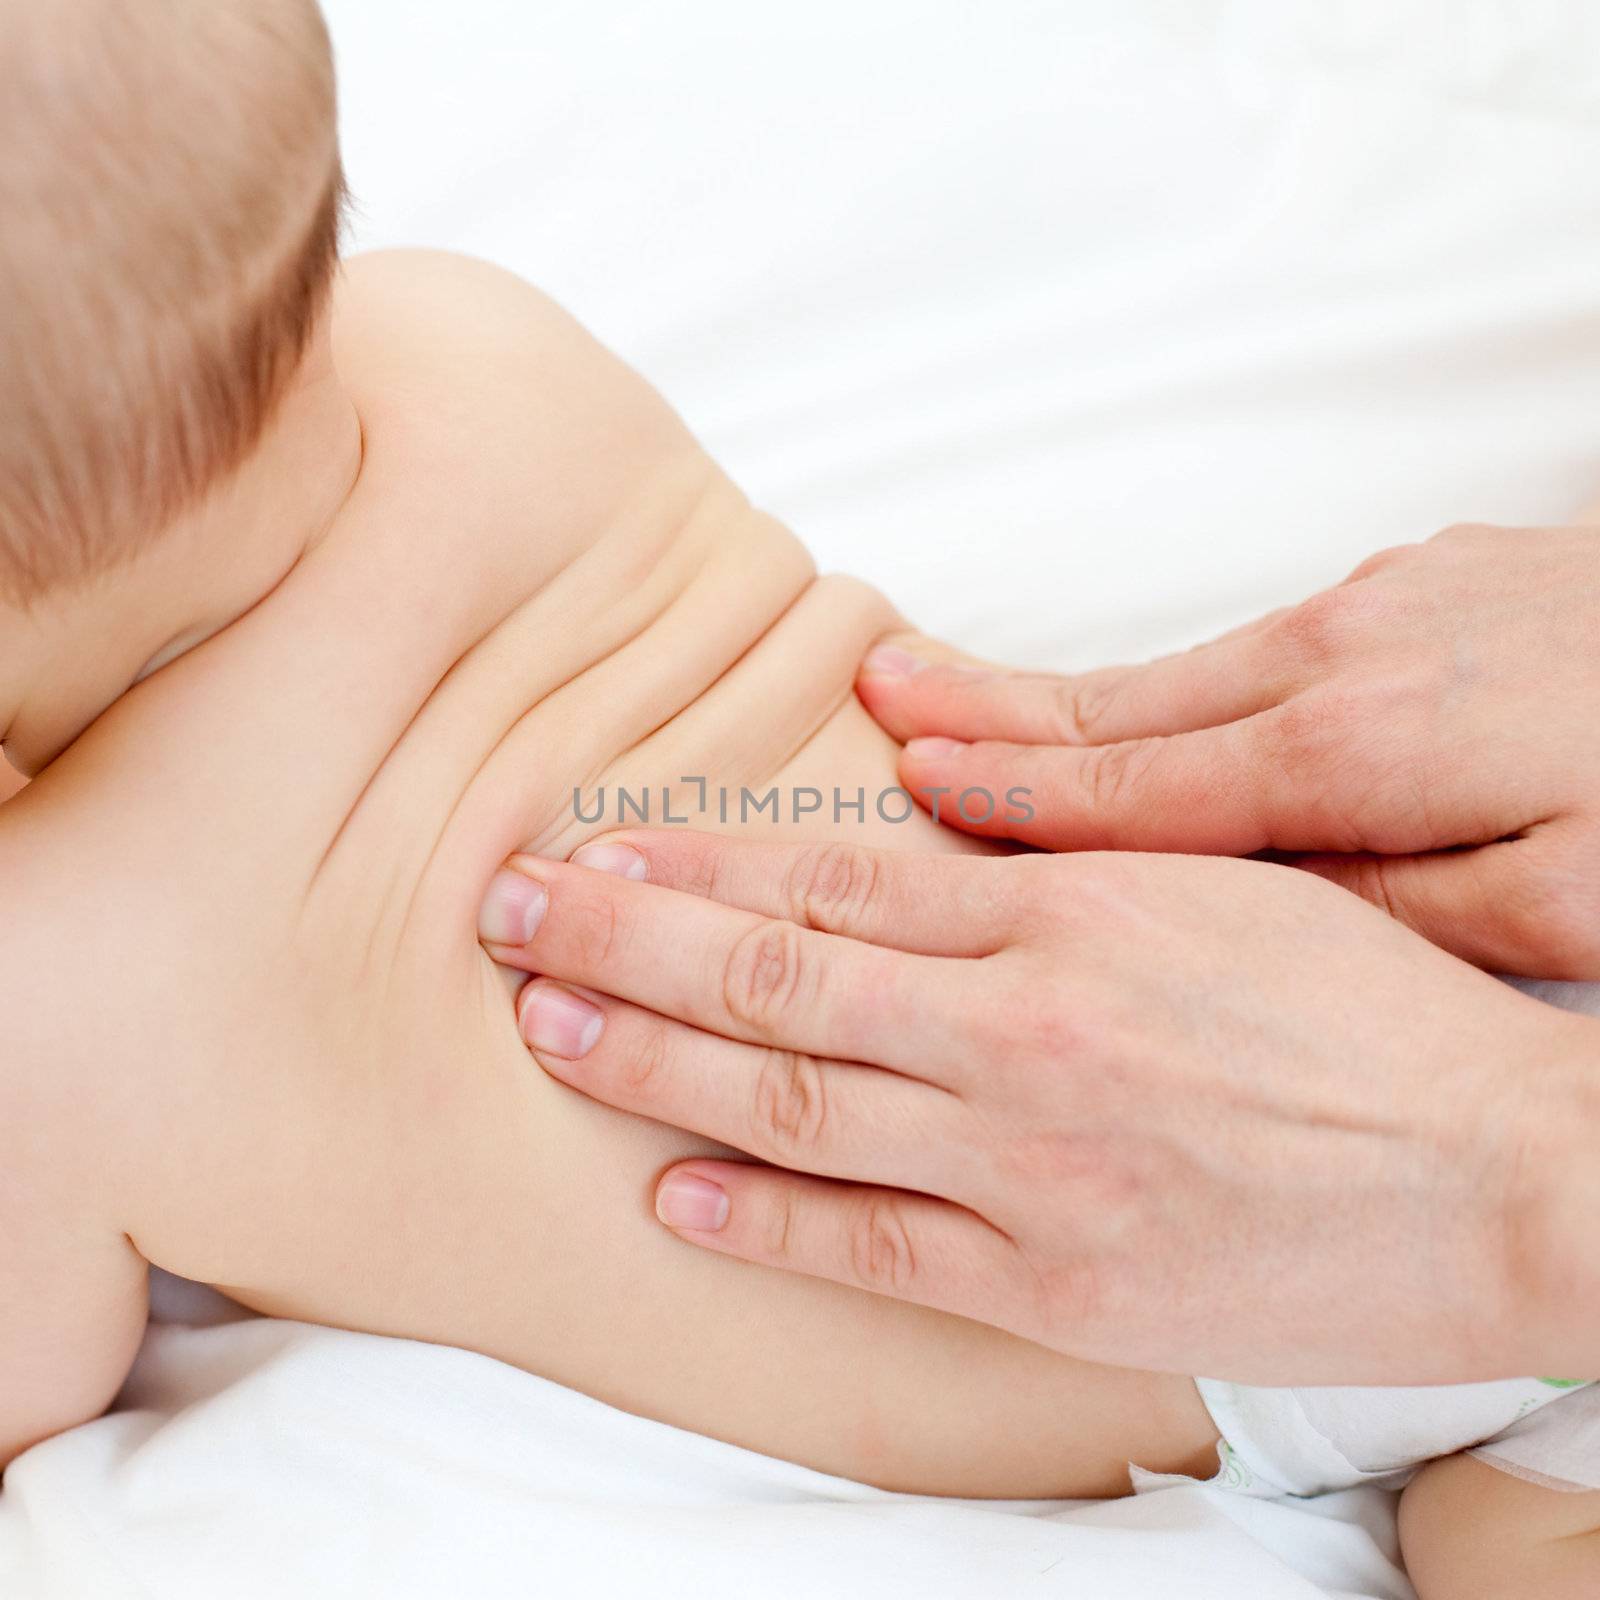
478, 856, 971, 1070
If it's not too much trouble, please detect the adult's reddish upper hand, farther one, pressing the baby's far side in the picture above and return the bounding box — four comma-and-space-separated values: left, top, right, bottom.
859, 528, 1600, 978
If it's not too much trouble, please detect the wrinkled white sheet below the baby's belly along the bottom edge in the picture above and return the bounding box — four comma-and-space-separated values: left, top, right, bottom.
0, 1286, 1406, 1600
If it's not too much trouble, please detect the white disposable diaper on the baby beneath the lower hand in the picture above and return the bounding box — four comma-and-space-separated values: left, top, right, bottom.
1164, 1378, 1600, 1498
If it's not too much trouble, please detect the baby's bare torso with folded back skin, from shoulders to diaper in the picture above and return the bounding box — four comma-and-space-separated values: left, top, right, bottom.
0, 256, 1214, 1496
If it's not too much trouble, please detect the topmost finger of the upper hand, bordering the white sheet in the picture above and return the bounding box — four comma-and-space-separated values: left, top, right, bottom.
856, 629, 1294, 746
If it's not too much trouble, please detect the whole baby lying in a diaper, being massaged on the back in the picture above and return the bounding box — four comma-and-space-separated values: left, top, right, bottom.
0, 0, 1600, 1600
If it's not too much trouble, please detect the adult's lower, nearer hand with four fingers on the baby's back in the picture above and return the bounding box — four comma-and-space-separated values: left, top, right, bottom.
480, 830, 1600, 1382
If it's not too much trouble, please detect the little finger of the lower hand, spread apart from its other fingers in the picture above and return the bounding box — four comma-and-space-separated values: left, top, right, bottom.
656, 1160, 1045, 1338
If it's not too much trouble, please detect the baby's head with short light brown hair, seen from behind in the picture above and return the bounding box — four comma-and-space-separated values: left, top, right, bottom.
0, 0, 344, 768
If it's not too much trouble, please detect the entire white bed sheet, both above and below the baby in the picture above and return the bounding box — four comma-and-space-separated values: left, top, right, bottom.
0, 0, 1600, 1600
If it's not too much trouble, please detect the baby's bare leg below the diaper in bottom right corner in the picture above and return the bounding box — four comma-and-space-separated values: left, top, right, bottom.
1400, 1456, 1600, 1600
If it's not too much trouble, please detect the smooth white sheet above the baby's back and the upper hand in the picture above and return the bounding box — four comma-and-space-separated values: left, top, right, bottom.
333, 0, 1600, 662
